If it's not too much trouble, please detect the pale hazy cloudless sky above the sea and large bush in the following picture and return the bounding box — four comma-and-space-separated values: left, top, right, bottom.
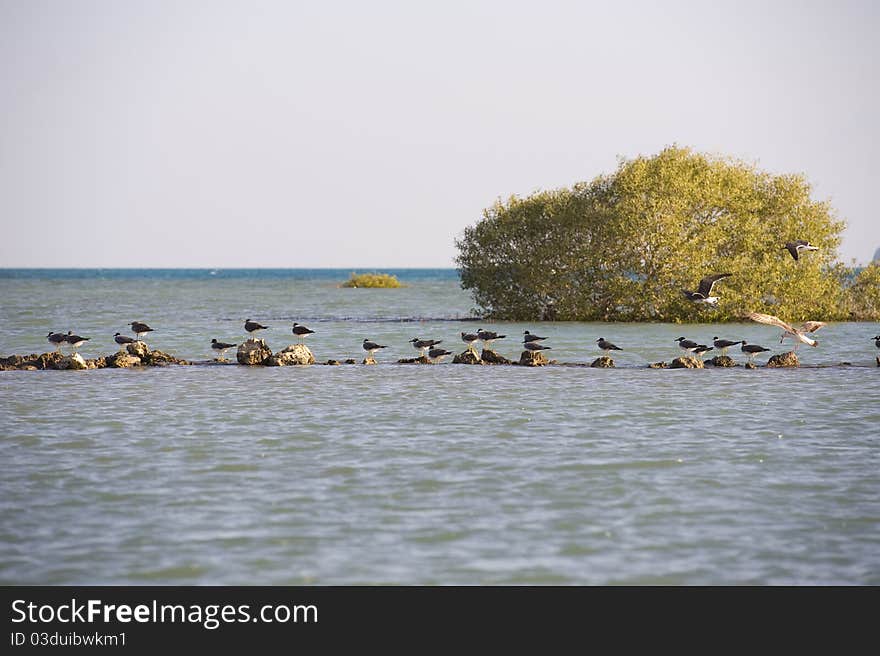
0, 0, 880, 269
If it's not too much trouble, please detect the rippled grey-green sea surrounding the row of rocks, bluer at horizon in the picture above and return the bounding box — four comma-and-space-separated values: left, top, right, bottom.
0, 269, 880, 586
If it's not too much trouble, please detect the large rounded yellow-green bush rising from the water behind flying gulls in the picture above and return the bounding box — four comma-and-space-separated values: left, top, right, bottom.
456, 147, 847, 321
